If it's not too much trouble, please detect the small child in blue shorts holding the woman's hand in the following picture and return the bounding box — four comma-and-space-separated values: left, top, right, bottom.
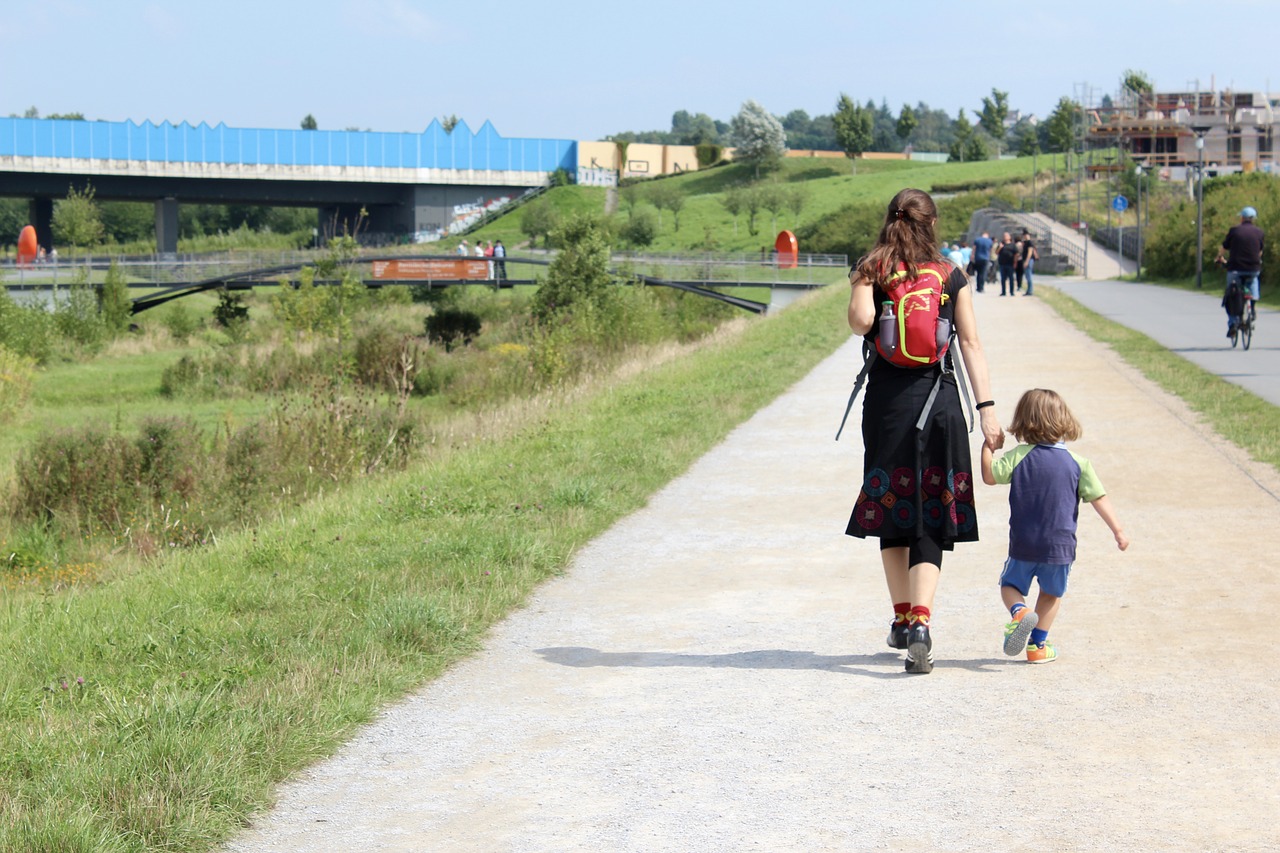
982, 388, 1129, 663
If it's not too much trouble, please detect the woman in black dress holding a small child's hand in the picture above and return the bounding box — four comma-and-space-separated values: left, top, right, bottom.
845, 190, 1005, 672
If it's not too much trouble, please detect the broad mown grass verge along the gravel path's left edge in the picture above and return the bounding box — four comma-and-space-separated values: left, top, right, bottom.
0, 275, 849, 852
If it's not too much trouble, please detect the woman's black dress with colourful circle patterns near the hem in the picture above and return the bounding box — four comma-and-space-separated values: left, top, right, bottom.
845, 263, 978, 551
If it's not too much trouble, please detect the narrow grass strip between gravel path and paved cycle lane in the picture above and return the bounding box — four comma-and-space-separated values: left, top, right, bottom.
1037, 287, 1280, 470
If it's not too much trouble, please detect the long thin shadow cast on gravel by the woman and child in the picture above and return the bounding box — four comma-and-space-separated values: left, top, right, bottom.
536, 646, 1018, 679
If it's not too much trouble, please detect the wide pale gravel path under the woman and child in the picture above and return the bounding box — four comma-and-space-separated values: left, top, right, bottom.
229, 289, 1280, 853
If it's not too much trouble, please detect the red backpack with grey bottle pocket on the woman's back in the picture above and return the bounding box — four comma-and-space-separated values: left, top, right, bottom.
876, 263, 951, 368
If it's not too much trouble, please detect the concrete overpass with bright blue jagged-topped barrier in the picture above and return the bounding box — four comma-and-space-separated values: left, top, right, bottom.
0, 118, 577, 254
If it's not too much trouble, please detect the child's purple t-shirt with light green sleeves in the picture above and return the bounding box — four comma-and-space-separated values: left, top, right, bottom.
991, 443, 1107, 565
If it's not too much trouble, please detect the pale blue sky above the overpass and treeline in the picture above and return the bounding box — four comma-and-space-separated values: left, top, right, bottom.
0, 0, 1280, 140
